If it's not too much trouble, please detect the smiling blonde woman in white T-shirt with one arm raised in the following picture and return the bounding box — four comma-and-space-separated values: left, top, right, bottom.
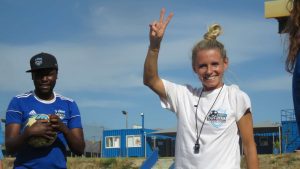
144, 9, 258, 169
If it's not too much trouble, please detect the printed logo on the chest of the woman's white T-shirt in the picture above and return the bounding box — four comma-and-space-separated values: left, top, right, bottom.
207, 109, 227, 128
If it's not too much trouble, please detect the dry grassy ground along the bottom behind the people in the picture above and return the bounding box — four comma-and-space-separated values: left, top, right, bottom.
3, 153, 300, 169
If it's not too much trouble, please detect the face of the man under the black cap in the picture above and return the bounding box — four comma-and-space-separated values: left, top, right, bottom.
32, 69, 57, 99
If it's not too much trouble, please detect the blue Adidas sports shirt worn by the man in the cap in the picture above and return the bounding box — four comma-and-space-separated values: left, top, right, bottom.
6, 91, 82, 169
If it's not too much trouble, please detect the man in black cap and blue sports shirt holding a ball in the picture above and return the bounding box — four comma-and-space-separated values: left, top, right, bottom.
5, 53, 85, 169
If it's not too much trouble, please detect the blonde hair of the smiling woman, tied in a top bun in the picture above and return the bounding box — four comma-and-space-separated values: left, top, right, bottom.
192, 24, 227, 69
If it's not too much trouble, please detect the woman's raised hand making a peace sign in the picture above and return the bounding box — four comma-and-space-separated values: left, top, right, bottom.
149, 8, 174, 49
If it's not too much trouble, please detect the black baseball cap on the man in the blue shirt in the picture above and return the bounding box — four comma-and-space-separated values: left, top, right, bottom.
26, 52, 58, 72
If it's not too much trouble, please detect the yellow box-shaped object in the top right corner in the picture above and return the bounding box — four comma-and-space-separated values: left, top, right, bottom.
265, 0, 292, 18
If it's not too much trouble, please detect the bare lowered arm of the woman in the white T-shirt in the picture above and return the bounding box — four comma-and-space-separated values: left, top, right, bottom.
237, 109, 258, 169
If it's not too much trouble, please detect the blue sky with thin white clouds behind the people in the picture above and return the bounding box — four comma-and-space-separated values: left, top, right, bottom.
0, 0, 292, 140
